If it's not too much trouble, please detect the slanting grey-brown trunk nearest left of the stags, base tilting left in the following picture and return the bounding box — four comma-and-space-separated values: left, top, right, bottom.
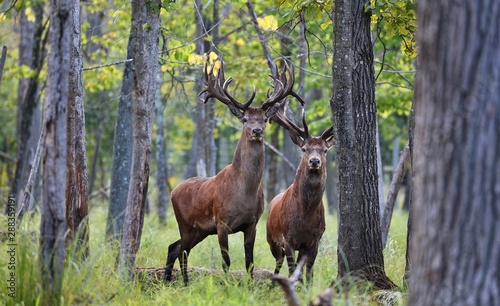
118, 0, 161, 278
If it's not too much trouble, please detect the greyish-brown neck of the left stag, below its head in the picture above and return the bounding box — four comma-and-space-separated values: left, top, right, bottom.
232, 133, 264, 188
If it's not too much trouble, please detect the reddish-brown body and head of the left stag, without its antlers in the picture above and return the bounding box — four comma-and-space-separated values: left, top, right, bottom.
165, 108, 274, 284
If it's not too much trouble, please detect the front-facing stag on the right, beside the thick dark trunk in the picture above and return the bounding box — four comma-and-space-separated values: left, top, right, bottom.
266, 101, 334, 283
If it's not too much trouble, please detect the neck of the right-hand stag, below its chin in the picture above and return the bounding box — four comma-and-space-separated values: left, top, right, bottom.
294, 163, 326, 208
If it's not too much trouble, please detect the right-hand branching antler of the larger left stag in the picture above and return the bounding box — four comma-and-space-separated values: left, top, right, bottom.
262, 60, 305, 110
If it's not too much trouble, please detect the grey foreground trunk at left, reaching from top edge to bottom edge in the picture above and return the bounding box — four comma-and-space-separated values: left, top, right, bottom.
39, 0, 73, 305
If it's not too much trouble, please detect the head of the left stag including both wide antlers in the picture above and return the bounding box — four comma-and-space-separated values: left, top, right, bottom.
199, 60, 302, 141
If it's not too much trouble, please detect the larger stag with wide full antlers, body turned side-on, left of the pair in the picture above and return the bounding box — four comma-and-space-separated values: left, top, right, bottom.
165, 62, 296, 285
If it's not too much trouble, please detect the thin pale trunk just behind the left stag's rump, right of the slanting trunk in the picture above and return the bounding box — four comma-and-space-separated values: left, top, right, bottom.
155, 74, 169, 225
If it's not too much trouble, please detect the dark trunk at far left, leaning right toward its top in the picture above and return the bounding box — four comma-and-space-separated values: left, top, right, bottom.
11, 3, 45, 213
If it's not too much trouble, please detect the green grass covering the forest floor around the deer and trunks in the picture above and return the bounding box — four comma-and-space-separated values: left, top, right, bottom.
0, 204, 407, 306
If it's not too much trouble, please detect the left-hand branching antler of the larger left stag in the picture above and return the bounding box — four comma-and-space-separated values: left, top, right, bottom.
198, 60, 255, 118
